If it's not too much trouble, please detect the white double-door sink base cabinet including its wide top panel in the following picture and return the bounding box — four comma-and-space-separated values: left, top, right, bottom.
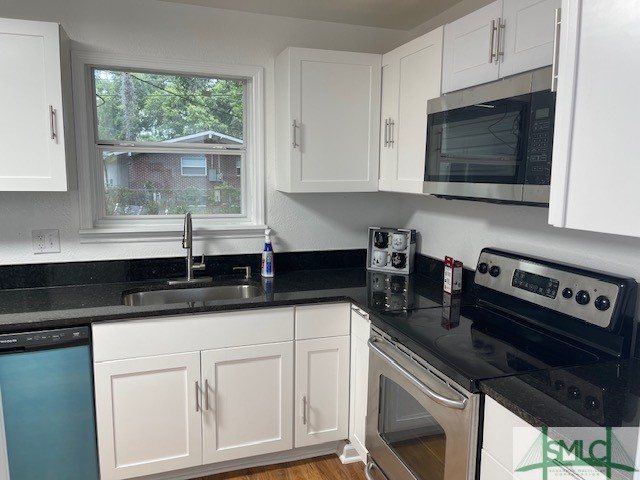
93, 307, 296, 480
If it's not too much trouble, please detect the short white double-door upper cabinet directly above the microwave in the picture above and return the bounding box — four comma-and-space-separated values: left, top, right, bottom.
442, 0, 560, 93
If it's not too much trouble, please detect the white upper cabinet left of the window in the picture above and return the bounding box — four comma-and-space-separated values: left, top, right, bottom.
0, 19, 75, 191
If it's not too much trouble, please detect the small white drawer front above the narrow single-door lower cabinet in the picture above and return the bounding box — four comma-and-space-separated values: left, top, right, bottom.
296, 303, 351, 340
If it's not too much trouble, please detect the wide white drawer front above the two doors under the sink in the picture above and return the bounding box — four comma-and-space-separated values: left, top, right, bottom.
92, 307, 293, 362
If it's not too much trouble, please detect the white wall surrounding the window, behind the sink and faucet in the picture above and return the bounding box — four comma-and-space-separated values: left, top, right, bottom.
0, 0, 407, 264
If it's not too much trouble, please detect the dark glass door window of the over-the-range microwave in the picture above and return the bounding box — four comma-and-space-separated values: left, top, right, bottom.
425, 95, 530, 184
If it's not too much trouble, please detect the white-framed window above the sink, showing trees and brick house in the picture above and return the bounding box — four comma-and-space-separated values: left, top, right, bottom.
73, 52, 264, 241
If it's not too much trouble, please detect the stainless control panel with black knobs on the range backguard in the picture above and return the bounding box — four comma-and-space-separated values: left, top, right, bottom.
475, 250, 620, 328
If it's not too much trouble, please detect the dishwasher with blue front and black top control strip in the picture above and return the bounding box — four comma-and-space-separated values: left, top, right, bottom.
0, 327, 98, 480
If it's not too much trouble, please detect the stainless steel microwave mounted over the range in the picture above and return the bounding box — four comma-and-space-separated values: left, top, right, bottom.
423, 68, 556, 205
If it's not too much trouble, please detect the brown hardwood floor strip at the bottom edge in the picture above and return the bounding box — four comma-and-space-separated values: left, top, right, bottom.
194, 455, 365, 480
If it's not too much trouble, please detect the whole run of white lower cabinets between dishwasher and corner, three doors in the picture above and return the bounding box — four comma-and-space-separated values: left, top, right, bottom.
93, 303, 350, 480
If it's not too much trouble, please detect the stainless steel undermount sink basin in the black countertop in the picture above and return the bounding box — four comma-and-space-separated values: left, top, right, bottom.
122, 281, 264, 306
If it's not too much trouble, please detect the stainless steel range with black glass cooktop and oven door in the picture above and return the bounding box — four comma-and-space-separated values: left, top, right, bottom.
366, 249, 638, 480
